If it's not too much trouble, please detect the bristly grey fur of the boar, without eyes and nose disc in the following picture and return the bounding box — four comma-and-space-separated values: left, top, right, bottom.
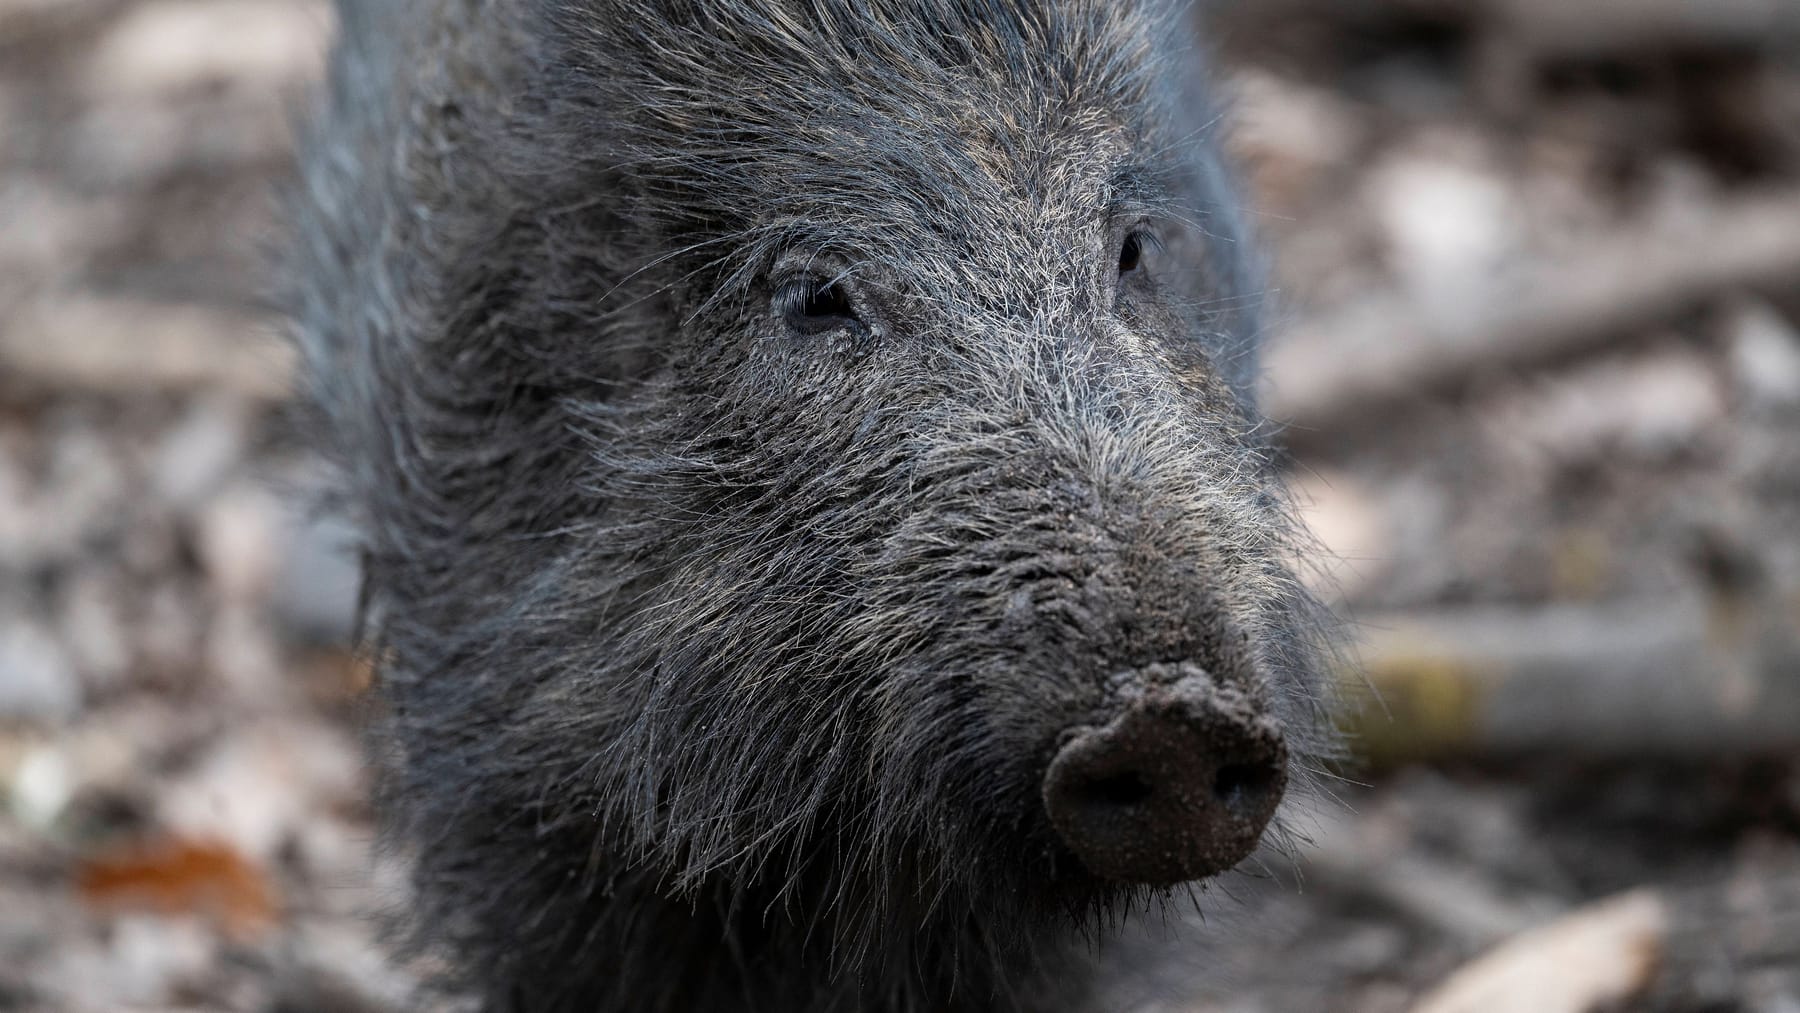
284, 0, 1330, 1013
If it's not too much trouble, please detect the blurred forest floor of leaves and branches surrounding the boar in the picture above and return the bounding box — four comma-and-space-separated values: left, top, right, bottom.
0, 0, 1800, 1013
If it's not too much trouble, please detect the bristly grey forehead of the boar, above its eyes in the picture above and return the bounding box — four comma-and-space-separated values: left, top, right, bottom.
556, 0, 1206, 282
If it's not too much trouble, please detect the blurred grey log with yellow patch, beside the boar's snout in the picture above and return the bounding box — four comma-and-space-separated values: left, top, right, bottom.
1352, 599, 1800, 763
